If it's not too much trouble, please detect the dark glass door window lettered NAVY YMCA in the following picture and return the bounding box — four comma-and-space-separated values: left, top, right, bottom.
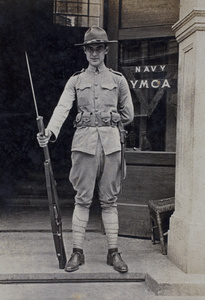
119, 38, 178, 152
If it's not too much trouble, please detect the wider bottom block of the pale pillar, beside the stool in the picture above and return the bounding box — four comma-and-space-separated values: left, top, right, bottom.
168, 213, 205, 274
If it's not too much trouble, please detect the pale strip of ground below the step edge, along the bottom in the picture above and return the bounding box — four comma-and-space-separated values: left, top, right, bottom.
0, 282, 154, 300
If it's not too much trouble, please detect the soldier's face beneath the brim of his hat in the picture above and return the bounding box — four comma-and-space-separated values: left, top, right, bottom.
84, 44, 108, 67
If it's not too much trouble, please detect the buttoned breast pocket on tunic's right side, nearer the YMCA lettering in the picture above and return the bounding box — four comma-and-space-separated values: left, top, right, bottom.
101, 82, 118, 107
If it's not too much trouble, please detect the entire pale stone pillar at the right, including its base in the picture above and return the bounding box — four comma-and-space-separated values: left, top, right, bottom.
168, 0, 205, 274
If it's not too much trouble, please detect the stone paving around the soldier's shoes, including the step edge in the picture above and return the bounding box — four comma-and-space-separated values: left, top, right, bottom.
0, 207, 205, 300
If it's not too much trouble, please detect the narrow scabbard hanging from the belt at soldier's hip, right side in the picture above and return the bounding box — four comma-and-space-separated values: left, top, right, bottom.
118, 121, 127, 194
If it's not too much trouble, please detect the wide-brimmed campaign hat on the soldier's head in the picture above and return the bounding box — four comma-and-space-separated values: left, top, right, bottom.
75, 26, 117, 46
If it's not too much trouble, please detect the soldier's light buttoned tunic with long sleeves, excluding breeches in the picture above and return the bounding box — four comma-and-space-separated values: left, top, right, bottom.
47, 67, 134, 155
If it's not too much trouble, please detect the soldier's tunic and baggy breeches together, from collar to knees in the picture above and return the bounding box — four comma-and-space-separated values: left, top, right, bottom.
47, 63, 133, 206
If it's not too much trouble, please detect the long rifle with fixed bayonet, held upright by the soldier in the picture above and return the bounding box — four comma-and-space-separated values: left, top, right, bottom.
25, 52, 66, 269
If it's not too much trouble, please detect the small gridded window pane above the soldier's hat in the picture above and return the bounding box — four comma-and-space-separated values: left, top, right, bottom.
53, 0, 102, 27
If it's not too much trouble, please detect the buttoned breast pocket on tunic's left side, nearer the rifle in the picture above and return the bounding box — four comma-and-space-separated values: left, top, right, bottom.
76, 83, 91, 107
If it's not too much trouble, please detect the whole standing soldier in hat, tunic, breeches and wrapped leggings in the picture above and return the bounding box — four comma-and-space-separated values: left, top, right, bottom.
37, 26, 134, 273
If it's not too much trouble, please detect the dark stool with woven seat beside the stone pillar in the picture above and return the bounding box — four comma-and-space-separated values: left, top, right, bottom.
148, 197, 175, 255
